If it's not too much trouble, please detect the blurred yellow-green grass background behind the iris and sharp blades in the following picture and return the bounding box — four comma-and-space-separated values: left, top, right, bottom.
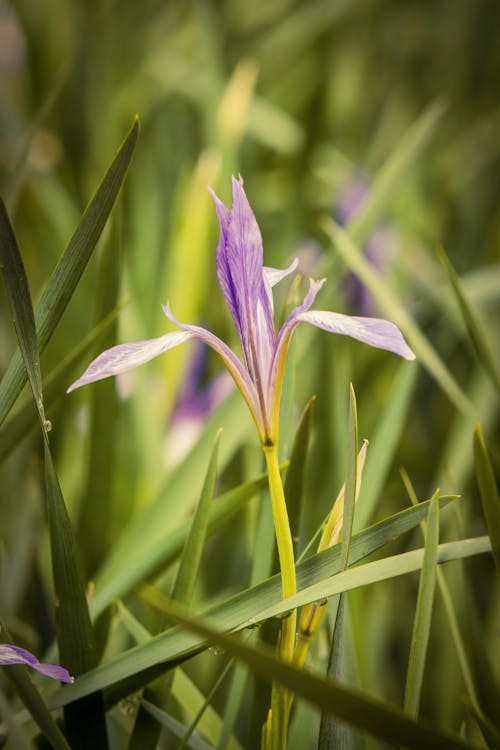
0, 0, 500, 747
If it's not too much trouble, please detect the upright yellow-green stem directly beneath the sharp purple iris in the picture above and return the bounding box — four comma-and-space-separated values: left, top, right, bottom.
264, 445, 297, 750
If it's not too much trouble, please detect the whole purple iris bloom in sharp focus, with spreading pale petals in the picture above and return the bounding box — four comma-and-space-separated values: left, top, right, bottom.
68, 177, 415, 446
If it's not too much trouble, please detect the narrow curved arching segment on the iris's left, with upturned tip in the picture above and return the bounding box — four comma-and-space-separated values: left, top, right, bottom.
162, 305, 265, 434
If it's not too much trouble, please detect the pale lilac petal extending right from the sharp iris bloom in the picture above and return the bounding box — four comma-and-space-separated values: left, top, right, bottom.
297, 310, 415, 359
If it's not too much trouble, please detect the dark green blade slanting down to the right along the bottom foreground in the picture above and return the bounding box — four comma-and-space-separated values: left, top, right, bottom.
157, 604, 476, 750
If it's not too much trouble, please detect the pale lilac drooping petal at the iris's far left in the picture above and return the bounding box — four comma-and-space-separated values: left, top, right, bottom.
66, 331, 193, 393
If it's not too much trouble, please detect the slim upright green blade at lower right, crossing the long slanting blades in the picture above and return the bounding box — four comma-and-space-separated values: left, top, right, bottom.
404, 492, 439, 717
